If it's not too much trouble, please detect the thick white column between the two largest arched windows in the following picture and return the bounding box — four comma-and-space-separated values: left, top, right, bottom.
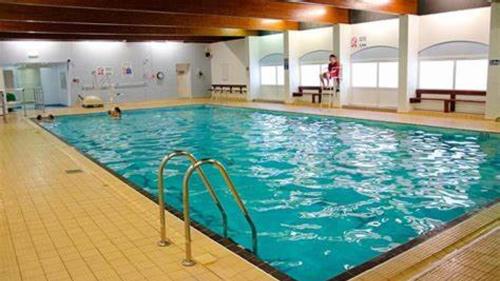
398, 15, 419, 112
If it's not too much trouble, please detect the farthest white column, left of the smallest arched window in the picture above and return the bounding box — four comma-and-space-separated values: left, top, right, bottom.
246, 36, 260, 101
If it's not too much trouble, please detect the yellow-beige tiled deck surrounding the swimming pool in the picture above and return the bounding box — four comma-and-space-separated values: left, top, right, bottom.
0, 99, 500, 281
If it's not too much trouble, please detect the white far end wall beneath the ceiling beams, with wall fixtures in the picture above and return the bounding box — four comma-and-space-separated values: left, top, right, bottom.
0, 41, 211, 103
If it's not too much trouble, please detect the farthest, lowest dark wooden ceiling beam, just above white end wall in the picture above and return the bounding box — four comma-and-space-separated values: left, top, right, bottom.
0, 32, 241, 43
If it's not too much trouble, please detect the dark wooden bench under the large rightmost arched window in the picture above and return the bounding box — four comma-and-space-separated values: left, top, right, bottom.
410, 89, 486, 113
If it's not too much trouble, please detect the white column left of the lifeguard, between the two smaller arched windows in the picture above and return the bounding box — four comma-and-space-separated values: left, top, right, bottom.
283, 30, 300, 103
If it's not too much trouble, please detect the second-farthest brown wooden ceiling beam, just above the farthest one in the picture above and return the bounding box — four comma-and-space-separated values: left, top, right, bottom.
0, 20, 258, 37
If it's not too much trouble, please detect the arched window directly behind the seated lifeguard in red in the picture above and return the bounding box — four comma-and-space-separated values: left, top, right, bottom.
299, 50, 332, 86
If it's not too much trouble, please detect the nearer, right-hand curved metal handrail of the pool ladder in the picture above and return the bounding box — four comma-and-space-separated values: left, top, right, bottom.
182, 159, 257, 266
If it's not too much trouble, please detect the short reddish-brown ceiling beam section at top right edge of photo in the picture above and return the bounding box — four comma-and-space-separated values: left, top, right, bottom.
281, 0, 418, 15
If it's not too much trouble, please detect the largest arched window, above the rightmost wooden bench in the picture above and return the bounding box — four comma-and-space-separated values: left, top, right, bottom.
418, 41, 489, 91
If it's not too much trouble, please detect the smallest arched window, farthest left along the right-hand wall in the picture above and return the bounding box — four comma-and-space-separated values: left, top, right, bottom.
259, 53, 285, 86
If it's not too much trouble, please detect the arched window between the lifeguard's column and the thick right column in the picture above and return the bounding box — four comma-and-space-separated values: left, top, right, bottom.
351, 46, 399, 88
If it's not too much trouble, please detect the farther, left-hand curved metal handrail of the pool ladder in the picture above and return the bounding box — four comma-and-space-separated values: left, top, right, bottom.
158, 150, 227, 247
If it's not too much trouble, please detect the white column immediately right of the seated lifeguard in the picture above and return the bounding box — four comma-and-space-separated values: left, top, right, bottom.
333, 24, 351, 106
